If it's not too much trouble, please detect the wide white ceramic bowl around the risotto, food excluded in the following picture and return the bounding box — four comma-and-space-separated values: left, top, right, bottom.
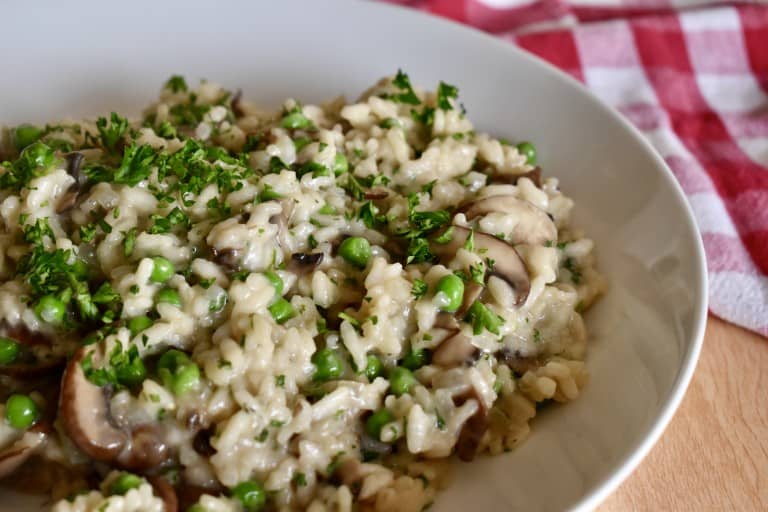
0, 0, 707, 511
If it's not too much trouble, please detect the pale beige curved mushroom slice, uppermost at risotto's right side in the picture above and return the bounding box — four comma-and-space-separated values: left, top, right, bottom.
462, 195, 557, 245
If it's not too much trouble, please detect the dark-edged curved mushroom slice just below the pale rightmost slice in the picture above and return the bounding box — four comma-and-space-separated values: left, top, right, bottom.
431, 226, 531, 304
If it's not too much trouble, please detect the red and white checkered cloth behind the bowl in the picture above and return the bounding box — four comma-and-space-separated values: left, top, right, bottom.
388, 0, 768, 336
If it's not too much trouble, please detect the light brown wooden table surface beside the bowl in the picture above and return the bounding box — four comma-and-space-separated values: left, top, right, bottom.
598, 316, 768, 512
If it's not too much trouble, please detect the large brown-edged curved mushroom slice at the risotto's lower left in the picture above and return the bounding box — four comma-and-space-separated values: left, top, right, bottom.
59, 347, 130, 462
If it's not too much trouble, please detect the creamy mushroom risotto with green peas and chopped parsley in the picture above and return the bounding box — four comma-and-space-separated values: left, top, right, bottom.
0, 72, 604, 512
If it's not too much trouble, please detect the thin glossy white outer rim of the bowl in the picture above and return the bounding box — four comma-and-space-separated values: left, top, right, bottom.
368, 2, 709, 511
